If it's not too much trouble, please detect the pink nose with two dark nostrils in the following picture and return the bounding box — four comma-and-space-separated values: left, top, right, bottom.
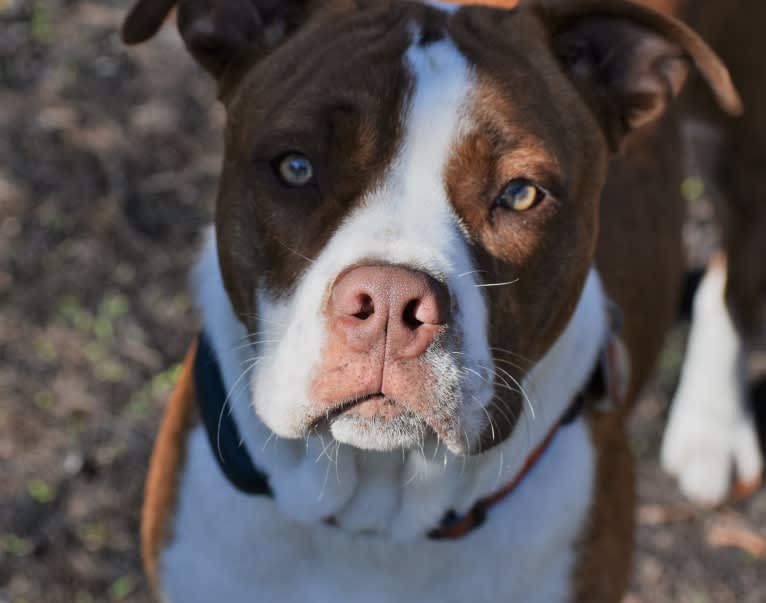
328, 266, 450, 360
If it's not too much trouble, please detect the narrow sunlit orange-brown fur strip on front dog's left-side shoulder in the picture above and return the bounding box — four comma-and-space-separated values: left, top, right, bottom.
141, 342, 197, 587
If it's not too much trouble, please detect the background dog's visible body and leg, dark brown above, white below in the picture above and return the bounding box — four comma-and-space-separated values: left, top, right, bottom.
655, 0, 766, 505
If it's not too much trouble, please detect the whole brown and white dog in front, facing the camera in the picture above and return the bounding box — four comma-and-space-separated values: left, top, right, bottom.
123, 0, 760, 603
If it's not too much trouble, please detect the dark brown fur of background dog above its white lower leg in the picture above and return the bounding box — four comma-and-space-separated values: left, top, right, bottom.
682, 0, 766, 341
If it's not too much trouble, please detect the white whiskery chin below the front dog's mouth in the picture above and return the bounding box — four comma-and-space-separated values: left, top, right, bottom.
330, 413, 434, 452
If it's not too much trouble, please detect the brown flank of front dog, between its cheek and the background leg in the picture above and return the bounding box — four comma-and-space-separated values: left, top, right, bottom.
596, 115, 684, 404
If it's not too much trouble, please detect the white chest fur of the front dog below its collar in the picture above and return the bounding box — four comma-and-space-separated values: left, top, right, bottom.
160, 420, 593, 603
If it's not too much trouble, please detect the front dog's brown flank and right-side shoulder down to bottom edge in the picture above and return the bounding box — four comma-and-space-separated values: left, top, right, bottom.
575, 116, 684, 603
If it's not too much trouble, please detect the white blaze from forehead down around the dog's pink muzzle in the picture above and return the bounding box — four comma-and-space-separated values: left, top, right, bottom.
253, 32, 492, 448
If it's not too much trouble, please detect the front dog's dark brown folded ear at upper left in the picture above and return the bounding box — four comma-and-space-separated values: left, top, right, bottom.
122, 0, 312, 80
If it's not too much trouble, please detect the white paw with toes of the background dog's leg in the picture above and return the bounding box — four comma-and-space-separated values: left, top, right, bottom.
661, 400, 763, 506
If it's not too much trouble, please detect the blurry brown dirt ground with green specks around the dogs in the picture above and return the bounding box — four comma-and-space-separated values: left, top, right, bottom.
0, 0, 766, 603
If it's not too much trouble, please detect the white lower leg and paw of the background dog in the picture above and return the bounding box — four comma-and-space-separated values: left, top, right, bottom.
661, 266, 763, 505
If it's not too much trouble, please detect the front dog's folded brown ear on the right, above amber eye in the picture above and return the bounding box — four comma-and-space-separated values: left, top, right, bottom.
527, 0, 742, 149
